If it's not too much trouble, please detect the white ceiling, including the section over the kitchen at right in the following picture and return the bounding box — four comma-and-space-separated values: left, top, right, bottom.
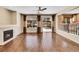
4, 6, 79, 14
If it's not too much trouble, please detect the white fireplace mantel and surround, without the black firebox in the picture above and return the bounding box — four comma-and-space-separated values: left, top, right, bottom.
0, 25, 16, 45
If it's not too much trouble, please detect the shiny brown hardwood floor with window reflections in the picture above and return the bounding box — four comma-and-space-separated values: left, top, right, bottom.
0, 33, 79, 52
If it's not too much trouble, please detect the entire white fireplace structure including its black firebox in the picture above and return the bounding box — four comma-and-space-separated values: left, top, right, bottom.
0, 25, 15, 45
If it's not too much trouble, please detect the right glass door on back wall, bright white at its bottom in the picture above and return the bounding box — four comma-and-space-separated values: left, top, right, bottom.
41, 16, 52, 32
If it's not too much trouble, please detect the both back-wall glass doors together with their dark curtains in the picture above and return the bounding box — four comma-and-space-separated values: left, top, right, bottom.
24, 15, 55, 33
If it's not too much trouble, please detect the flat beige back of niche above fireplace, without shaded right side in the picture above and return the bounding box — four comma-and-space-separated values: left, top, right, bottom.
0, 7, 11, 25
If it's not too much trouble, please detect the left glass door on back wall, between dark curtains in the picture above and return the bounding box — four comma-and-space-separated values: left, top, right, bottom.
26, 16, 37, 33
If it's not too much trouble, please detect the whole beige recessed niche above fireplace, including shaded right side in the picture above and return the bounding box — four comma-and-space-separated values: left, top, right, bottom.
0, 7, 16, 25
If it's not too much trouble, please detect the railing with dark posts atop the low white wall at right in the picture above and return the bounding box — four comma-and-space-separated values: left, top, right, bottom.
59, 23, 79, 35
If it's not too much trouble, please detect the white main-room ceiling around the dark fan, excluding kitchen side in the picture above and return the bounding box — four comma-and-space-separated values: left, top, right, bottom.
4, 6, 66, 14
